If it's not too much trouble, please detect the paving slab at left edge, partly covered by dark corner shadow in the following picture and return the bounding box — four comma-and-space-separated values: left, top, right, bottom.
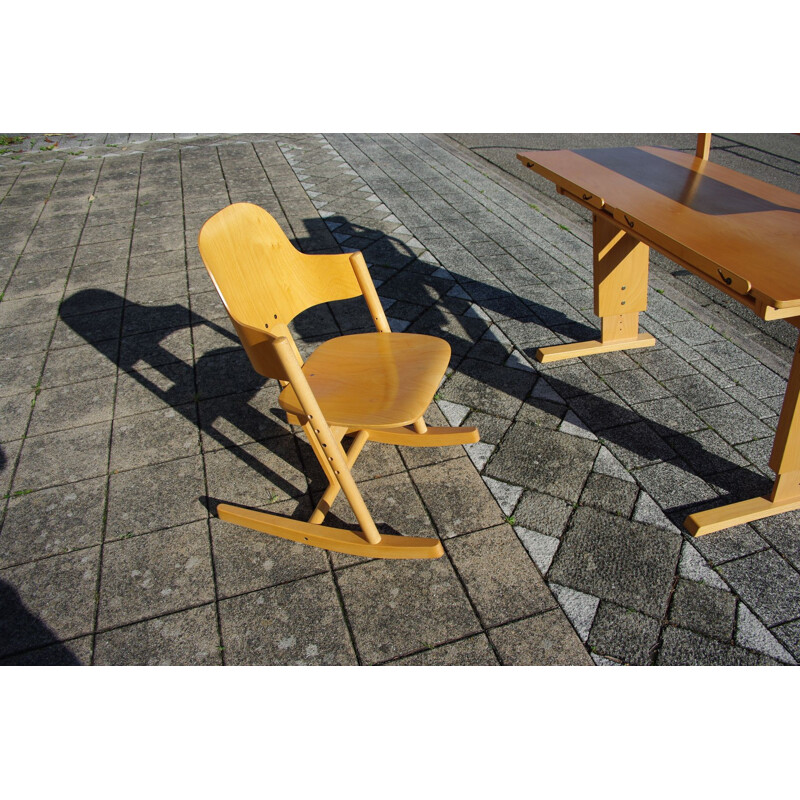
0, 547, 100, 656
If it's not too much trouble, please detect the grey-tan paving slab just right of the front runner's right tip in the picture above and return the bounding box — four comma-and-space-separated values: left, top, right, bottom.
445, 525, 556, 626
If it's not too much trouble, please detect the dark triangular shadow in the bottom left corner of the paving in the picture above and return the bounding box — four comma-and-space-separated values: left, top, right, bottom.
0, 580, 80, 667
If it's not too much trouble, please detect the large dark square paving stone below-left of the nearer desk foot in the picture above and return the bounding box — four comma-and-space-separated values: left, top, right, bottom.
548, 508, 681, 619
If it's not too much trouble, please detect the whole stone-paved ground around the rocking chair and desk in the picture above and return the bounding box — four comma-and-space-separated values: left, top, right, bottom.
0, 134, 800, 665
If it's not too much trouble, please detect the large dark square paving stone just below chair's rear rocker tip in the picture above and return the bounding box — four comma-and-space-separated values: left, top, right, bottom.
485, 422, 599, 502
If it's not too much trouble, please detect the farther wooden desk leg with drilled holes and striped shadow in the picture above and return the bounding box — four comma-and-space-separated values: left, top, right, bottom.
536, 214, 656, 363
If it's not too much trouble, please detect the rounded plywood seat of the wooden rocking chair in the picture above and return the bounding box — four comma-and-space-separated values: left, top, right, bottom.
279, 333, 450, 429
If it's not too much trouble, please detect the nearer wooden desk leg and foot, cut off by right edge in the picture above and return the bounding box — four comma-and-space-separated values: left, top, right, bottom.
684, 341, 800, 536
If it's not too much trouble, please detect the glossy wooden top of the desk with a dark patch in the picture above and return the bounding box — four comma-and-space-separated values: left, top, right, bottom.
517, 147, 800, 318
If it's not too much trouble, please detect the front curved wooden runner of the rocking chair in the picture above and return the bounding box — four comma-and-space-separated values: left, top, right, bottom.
217, 503, 444, 558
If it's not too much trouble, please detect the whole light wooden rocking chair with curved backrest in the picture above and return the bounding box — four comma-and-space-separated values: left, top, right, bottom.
198, 203, 479, 558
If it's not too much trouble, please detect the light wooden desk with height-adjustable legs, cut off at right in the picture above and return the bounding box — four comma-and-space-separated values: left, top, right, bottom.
517, 147, 800, 536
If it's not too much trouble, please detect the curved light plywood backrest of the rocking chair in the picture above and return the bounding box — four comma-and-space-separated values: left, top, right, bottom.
197, 203, 362, 381
